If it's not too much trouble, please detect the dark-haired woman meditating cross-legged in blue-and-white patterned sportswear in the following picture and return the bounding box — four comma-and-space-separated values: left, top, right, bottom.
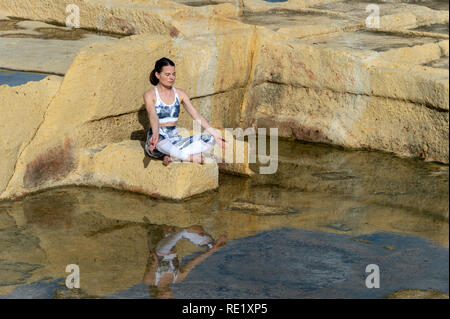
144, 58, 225, 166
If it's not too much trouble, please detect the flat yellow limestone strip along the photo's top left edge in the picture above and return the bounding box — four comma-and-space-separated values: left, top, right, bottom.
0, 0, 239, 37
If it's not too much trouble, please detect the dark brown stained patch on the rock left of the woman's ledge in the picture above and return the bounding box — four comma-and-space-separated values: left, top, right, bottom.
23, 139, 76, 188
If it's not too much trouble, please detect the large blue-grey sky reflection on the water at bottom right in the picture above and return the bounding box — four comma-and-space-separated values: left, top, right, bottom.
174, 228, 448, 298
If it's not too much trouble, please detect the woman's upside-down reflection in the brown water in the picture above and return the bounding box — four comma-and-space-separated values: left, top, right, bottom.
144, 225, 226, 298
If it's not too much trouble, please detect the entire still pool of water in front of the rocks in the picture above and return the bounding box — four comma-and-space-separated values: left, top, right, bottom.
0, 141, 449, 298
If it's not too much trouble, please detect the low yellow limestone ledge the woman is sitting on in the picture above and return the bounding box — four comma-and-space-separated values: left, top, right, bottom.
74, 141, 219, 199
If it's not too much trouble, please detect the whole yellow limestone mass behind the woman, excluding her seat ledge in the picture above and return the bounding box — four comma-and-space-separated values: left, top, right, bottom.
0, 0, 449, 198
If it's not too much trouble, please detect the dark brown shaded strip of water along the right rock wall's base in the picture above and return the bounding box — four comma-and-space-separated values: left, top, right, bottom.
251, 140, 449, 218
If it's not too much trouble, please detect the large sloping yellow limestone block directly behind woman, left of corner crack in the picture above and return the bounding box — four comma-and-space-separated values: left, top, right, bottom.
0, 29, 253, 199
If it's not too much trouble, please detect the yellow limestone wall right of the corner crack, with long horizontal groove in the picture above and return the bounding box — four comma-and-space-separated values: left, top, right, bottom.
242, 30, 449, 163
